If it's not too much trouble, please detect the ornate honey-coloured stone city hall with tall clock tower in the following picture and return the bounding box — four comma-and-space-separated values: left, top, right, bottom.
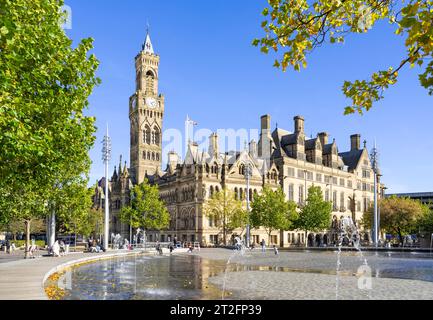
94, 34, 382, 246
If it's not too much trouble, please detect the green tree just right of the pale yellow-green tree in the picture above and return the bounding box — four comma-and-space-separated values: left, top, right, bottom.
250, 187, 298, 245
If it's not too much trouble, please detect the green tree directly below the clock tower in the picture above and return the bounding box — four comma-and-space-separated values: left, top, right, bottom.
120, 180, 170, 236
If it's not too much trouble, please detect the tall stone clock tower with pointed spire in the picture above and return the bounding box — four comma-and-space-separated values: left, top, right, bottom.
129, 32, 164, 184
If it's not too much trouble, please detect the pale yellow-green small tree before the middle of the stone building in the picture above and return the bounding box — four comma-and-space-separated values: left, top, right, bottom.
203, 187, 248, 245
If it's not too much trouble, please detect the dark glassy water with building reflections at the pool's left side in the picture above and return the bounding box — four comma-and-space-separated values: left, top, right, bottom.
64, 255, 228, 300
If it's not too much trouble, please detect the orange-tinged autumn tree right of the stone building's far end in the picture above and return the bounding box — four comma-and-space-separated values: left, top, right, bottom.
363, 196, 428, 245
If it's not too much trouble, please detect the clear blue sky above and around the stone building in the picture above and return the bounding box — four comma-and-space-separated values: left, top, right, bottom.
66, 0, 433, 192
